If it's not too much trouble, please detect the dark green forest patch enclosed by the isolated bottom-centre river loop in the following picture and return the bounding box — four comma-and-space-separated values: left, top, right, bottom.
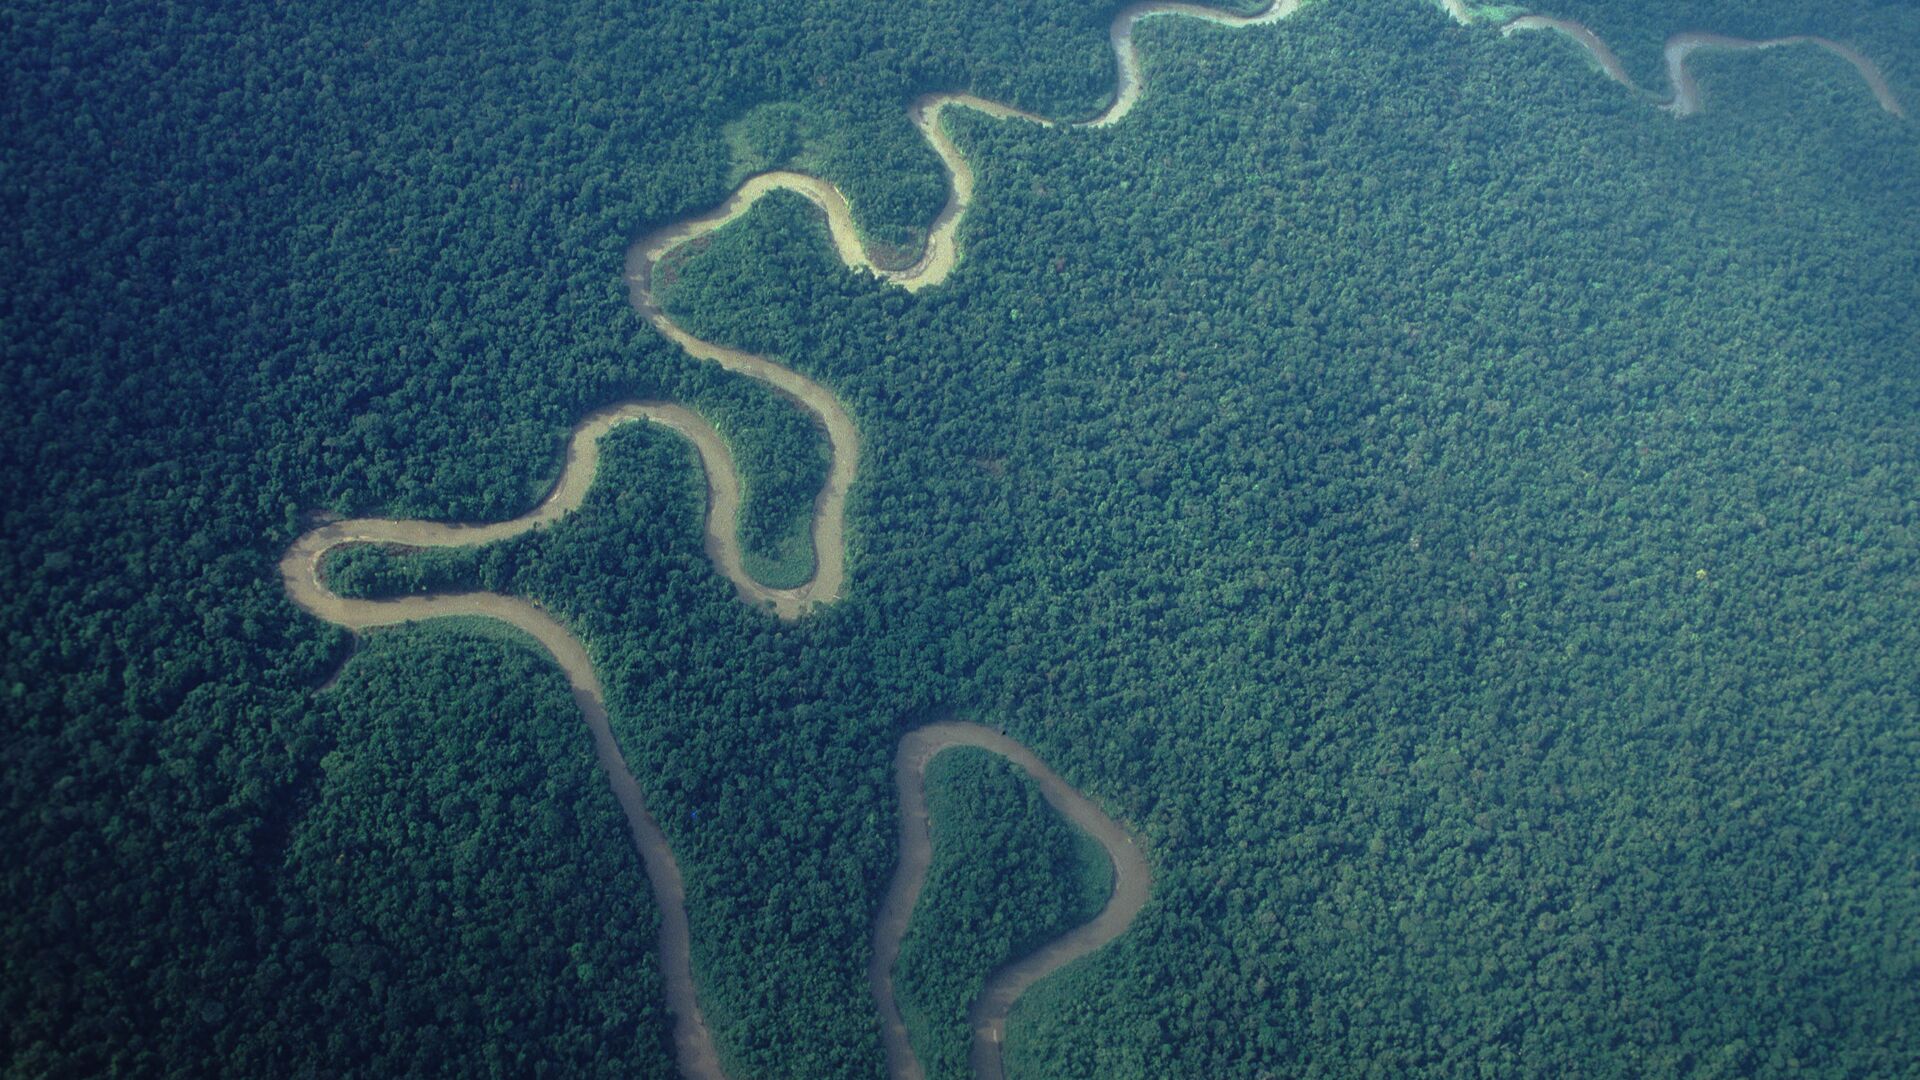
893, 748, 1114, 1076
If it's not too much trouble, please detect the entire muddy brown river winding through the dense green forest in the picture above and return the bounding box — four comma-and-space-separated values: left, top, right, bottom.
280, 0, 1905, 1080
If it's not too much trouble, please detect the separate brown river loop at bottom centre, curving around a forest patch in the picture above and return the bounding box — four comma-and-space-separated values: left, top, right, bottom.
868, 721, 1154, 1080
